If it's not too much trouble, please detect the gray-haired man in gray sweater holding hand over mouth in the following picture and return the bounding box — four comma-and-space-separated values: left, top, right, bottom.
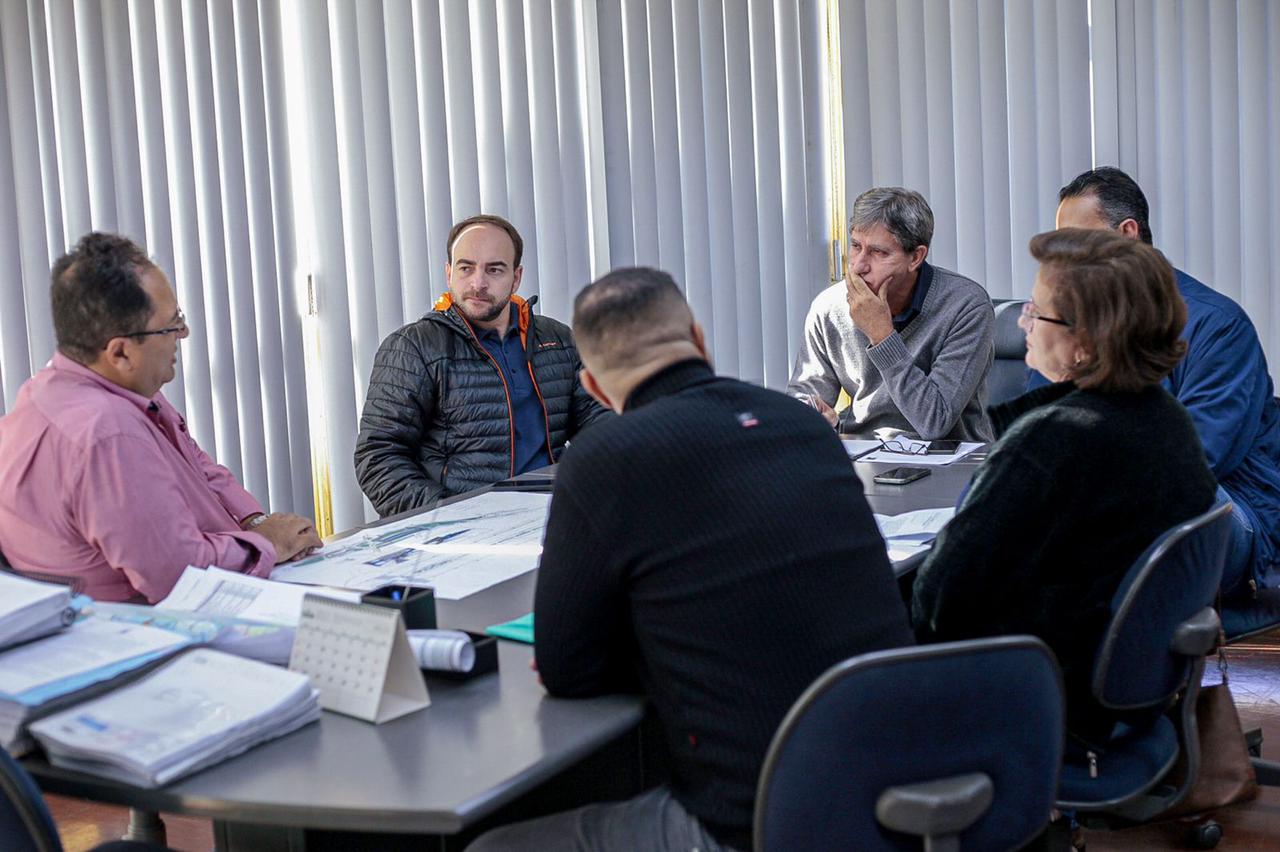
787, 187, 996, 441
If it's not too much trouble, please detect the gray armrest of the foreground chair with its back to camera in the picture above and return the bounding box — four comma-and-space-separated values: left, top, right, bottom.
876, 773, 996, 837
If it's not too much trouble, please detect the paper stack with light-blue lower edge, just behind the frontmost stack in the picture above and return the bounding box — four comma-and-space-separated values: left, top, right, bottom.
0, 618, 191, 753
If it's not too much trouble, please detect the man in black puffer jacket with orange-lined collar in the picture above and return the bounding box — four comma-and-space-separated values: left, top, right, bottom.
356, 216, 607, 517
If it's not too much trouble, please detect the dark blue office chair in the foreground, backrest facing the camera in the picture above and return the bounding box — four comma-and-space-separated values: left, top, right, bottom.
755, 636, 1065, 852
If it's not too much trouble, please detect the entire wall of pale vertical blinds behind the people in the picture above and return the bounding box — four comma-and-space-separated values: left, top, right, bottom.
0, 0, 1280, 528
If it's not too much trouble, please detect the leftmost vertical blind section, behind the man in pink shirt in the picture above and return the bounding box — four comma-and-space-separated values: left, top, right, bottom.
0, 0, 311, 510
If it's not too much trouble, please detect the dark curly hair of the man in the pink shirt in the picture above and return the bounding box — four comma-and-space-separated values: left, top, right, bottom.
50, 232, 155, 363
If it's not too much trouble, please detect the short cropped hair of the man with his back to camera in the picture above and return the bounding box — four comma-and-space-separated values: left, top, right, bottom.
573, 266, 692, 368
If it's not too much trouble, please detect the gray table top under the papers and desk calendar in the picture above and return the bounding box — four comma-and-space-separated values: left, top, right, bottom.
23, 450, 978, 834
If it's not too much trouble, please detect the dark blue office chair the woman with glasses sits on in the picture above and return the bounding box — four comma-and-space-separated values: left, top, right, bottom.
1057, 503, 1231, 828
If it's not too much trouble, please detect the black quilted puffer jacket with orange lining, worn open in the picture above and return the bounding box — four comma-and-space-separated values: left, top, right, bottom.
356, 294, 604, 517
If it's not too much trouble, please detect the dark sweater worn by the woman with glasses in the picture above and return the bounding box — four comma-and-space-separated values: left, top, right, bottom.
911, 383, 1217, 742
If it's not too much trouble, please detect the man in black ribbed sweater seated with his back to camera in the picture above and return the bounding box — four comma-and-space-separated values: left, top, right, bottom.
471, 269, 911, 852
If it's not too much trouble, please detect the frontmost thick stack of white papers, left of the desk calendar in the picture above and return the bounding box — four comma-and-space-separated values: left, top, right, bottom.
31, 649, 320, 787
